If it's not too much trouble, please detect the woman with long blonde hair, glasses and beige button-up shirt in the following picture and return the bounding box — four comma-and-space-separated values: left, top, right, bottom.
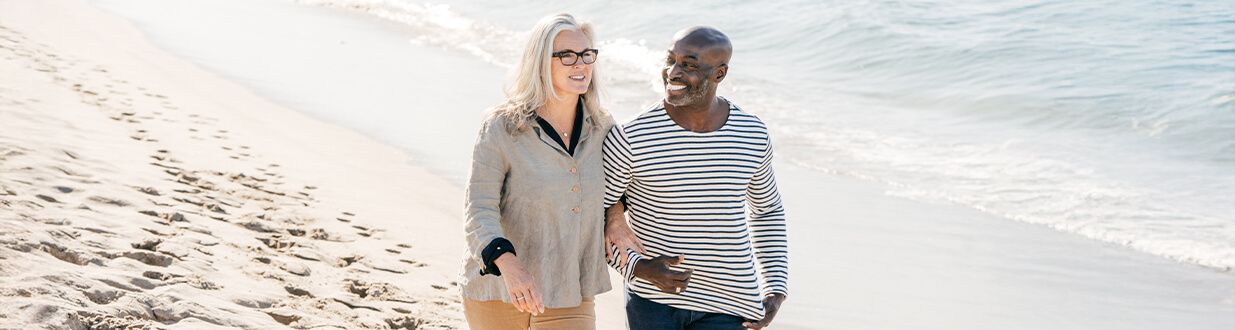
462, 14, 613, 330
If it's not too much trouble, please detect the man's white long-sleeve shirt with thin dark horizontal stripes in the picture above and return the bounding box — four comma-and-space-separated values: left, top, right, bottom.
604, 103, 789, 320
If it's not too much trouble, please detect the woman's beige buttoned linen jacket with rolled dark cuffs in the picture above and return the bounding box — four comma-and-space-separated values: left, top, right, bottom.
462, 107, 614, 308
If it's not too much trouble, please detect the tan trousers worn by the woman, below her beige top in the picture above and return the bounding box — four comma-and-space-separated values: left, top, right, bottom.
463, 298, 597, 330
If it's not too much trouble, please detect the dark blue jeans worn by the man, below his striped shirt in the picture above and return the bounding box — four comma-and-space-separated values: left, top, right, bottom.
626, 292, 746, 330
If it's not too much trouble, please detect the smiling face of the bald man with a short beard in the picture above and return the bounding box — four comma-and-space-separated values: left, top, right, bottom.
661, 40, 719, 106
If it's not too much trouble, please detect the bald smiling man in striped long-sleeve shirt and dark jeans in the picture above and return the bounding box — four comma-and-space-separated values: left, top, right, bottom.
604, 27, 789, 330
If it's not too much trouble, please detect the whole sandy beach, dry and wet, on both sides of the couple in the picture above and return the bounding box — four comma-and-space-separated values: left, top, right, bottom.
0, 0, 1235, 329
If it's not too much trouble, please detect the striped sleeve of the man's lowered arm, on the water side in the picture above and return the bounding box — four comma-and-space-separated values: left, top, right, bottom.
746, 134, 789, 295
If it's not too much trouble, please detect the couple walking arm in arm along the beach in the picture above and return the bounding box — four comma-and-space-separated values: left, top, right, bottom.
462, 14, 788, 330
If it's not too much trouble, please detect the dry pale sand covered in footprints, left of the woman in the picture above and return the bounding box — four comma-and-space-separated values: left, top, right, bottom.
0, 0, 462, 329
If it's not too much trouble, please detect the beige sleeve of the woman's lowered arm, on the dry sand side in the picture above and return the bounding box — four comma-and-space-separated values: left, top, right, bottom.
463, 120, 510, 275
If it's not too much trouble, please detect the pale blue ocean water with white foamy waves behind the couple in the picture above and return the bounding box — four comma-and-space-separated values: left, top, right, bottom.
298, 0, 1235, 272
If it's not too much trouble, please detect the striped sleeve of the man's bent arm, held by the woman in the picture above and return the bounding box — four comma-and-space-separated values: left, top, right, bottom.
603, 125, 642, 281
